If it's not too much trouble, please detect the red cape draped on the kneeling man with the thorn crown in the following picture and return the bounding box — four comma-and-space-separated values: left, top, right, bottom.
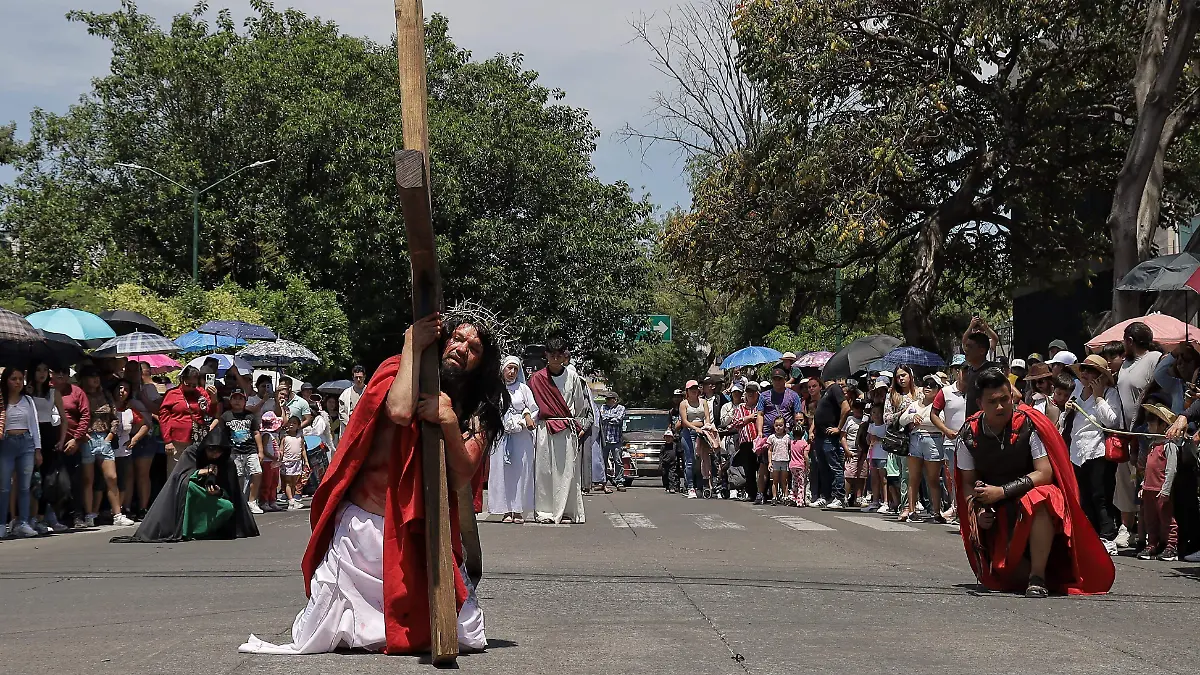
301, 356, 467, 653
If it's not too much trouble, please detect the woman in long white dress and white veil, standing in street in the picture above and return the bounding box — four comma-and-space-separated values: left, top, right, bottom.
487, 357, 538, 525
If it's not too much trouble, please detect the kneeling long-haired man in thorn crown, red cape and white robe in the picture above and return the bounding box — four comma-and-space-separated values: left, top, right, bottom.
239, 315, 509, 655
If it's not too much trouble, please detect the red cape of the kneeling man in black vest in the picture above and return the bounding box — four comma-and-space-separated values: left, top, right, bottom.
954, 404, 1116, 595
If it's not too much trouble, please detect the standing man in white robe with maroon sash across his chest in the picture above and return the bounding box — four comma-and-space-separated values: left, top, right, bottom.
529, 340, 595, 524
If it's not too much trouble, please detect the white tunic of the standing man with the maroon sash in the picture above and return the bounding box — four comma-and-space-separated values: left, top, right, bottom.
534, 369, 593, 522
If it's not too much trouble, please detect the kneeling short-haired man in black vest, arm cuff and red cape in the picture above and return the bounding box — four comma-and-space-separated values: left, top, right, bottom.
956, 368, 1115, 598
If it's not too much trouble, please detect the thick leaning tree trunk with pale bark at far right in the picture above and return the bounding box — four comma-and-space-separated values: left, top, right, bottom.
1108, 0, 1200, 323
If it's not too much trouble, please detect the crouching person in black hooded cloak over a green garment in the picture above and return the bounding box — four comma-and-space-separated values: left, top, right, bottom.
112, 425, 258, 543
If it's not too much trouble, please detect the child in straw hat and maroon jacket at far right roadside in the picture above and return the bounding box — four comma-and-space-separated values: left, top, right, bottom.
1138, 404, 1180, 562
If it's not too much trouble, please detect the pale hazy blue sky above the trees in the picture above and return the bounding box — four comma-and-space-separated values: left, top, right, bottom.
0, 0, 690, 208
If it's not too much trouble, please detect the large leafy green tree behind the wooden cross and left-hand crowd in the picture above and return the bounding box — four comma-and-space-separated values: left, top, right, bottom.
0, 0, 652, 364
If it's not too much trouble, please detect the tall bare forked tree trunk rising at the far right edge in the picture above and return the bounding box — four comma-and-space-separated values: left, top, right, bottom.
1108, 0, 1198, 323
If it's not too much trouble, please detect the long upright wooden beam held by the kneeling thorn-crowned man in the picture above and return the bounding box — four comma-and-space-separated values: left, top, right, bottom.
395, 0, 458, 665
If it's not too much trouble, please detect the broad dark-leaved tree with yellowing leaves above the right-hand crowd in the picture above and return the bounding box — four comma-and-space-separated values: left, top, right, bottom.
720, 0, 1132, 350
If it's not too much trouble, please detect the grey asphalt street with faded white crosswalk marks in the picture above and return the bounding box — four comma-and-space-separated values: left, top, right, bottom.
0, 482, 1200, 675
